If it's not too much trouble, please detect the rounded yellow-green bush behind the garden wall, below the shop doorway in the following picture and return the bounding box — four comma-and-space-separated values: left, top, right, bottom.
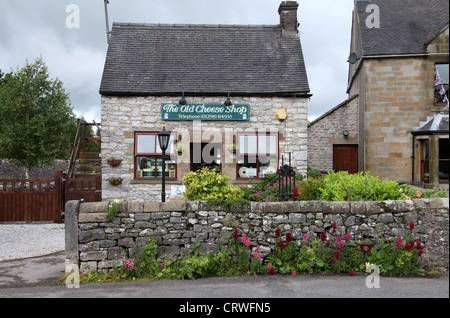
183, 168, 242, 201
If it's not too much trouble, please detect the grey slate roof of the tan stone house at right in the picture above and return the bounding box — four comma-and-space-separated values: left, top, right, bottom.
356, 0, 449, 56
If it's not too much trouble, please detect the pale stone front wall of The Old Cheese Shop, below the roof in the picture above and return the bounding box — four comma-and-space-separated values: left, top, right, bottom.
102, 96, 308, 201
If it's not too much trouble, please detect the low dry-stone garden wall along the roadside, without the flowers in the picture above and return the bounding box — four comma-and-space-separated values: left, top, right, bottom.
65, 198, 449, 272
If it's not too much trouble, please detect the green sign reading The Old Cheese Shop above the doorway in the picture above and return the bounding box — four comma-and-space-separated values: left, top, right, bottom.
161, 103, 250, 120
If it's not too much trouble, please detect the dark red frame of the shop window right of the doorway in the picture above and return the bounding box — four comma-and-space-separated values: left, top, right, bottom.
236, 132, 280, 180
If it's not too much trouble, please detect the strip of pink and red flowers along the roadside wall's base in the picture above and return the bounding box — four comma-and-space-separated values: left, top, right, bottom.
81, 223, 425, 281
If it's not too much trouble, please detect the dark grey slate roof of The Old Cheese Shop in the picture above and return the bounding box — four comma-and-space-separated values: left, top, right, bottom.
100, 23, 310, 96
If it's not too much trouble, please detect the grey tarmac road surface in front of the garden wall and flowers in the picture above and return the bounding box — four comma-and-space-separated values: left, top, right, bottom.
0, 252, 449, 300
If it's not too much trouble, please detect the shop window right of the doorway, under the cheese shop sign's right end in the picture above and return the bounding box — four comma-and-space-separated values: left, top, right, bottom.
236, 133, 278, 179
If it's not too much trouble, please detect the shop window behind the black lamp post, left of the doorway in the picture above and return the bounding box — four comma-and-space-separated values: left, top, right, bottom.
134, 132, 177, 180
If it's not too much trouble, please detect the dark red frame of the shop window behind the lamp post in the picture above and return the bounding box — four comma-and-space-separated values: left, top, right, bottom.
133, 131, 178, 180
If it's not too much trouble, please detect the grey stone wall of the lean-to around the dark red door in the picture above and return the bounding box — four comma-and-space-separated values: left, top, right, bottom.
308, 95, 359, 171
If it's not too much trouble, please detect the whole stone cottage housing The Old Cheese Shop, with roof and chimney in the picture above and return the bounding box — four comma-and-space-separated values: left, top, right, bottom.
100, 1, 311, 201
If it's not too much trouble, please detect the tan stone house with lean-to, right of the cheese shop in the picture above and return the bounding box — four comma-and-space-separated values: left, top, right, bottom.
308, 0, 449, 188
